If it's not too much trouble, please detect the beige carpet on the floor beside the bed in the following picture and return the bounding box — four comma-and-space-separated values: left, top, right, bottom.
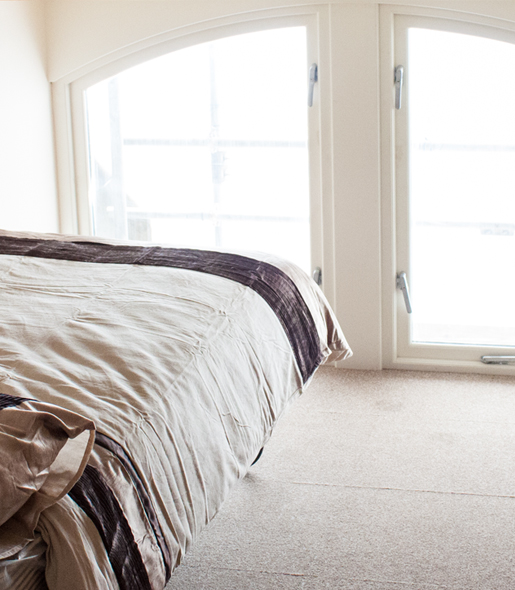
167, 368, 515, 590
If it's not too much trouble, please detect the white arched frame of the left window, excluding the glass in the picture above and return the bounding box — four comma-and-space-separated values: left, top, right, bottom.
52, 6, 335, 304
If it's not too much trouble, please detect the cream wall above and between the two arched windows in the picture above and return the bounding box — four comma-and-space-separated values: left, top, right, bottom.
44, 0, 515, 369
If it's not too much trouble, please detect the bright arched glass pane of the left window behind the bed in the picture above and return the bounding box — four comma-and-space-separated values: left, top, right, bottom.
86, 27, 310, 271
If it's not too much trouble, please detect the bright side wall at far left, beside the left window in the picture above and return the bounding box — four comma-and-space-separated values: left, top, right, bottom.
0, 0, 58, 231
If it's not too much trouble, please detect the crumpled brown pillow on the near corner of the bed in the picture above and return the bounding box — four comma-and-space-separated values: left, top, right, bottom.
0, 393, 95, 558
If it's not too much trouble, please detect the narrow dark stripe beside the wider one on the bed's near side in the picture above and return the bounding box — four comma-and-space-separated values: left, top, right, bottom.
95, 432, 172, 581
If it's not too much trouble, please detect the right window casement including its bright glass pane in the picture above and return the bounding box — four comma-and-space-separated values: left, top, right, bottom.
384, 11, 515, 370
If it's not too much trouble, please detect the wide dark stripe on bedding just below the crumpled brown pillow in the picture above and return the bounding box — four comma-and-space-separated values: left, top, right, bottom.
68, 465, 152, 590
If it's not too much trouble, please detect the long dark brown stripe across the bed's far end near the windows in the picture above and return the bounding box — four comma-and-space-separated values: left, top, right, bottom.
0, 236, 323, 383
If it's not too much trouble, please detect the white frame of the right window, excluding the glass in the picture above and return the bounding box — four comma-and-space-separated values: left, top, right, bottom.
379, 6, 515, 375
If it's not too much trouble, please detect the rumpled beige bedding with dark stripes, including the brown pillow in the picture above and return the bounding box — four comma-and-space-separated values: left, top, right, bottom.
0, 232, 351, 590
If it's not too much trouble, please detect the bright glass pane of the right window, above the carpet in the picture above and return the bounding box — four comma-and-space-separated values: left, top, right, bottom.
407, 29, 515, 346
